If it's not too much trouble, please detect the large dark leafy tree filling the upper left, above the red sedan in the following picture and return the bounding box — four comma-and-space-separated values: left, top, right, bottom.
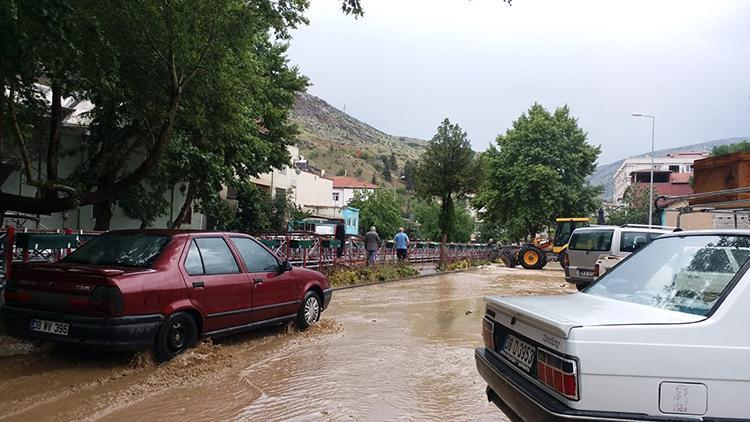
0, 0, 307, 222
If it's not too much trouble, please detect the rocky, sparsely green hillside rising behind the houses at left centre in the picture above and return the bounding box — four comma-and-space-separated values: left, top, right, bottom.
292, 94, 427, 184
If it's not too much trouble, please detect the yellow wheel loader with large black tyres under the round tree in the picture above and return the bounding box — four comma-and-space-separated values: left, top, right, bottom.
499, 217, 589, 270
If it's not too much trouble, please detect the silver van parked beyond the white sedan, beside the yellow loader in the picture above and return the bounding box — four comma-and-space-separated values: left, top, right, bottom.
565, 226, 673, 290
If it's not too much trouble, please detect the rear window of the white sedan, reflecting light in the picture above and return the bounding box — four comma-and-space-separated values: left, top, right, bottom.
585, 235, 750, 315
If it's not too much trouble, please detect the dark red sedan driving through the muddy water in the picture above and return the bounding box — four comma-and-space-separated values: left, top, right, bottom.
2, 230, 332, 360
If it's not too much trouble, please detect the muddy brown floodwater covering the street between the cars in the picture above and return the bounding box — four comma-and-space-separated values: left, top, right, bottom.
0, 265, 571, 421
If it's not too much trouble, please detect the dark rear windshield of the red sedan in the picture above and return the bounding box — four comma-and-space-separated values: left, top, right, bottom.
63, 233, 169, 268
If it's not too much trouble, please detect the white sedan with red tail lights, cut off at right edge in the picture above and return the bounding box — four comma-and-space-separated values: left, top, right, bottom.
475, 230, 750, 421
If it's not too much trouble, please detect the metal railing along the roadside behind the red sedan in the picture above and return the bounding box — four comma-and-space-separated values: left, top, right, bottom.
0, 227, 490, 287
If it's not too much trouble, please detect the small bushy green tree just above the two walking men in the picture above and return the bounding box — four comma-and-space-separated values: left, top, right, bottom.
349, 188, 404, 239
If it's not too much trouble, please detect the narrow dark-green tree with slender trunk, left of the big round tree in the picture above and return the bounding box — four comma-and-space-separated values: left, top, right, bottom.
414, 118, 481, 254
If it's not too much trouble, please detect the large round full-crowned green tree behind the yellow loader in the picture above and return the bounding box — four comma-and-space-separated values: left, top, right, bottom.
475, 104, 601, 238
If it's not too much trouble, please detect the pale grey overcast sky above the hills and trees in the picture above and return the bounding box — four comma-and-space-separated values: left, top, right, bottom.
289, 0, 750, 164
